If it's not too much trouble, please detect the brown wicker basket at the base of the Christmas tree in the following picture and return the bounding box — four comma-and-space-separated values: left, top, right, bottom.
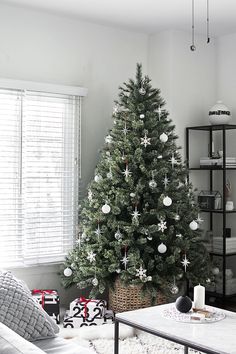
109, 278, 167, 313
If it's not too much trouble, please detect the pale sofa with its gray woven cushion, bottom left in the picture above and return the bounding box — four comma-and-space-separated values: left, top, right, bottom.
0, 271, 95, 354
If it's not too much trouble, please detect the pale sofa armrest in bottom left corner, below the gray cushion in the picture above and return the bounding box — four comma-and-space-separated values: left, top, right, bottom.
0, 322, 45, 354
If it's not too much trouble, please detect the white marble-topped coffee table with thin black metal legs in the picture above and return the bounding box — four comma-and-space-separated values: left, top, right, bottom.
114, 304, 236, 354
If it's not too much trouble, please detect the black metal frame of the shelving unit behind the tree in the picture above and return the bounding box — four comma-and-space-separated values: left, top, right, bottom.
186, 124, 236, 306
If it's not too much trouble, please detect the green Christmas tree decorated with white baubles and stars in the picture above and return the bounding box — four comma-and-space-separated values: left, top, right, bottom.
62, 64, 208, 297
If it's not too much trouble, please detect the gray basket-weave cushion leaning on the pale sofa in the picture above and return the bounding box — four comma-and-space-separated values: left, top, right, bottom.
0, 272, 59, 341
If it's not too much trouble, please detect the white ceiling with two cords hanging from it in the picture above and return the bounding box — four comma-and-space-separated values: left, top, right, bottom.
0, 0, 236, 37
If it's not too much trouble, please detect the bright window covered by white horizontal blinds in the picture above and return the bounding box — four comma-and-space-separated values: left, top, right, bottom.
0, 83, 87, 267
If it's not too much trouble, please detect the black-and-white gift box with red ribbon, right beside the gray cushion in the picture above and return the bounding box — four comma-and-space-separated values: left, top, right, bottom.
31, 289, 60, 324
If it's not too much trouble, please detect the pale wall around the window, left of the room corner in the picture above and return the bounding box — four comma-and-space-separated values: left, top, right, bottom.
0, 5, 147, 303
